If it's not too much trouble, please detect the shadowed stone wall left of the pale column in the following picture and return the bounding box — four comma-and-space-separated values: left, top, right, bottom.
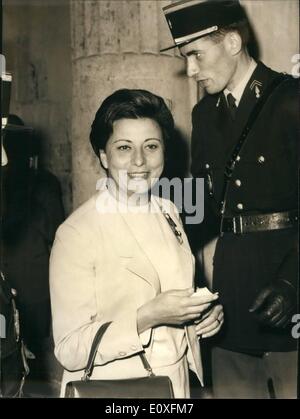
2, 0, 72, 213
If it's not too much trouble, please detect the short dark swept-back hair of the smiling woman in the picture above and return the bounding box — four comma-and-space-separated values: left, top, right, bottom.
90, 89, 174, 157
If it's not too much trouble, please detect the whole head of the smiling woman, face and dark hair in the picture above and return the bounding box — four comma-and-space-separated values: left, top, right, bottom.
90, 89, 174, 202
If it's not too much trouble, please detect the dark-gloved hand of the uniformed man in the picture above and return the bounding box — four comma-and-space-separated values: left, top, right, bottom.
249, 280, 297, 328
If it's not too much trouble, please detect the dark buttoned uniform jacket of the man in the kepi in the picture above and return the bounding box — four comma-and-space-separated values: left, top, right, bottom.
192, 62, 299, 353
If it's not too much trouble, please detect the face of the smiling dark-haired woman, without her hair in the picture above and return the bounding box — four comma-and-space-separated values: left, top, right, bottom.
100, 118, 164, 196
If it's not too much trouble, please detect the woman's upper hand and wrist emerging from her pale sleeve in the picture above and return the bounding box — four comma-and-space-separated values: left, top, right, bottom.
138, 288, 219, 333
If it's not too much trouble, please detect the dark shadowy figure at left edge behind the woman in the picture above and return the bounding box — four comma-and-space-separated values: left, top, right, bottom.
1, 115, 64, 396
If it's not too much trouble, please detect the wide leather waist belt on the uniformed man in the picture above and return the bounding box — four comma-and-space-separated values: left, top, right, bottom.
221, 210, 298, 234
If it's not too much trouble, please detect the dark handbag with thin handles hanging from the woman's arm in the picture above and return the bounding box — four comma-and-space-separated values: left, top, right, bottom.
65, 322, 174, 399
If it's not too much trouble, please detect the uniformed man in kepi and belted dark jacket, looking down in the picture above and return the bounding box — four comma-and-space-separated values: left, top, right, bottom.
164, 0, 299, 398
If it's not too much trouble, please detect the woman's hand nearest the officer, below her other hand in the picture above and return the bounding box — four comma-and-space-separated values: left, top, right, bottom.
195, 304, 224, 338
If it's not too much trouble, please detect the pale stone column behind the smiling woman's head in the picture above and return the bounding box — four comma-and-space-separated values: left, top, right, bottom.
71, 0, 196, 208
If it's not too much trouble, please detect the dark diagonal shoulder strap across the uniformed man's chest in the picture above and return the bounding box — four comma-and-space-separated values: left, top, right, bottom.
221, 73, 290, 230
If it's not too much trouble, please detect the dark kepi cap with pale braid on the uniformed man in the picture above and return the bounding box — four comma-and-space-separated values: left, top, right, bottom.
160, 0, 246, 52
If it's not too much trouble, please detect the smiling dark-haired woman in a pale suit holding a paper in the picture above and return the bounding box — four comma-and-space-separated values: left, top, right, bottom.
50, 89, 223, 398
